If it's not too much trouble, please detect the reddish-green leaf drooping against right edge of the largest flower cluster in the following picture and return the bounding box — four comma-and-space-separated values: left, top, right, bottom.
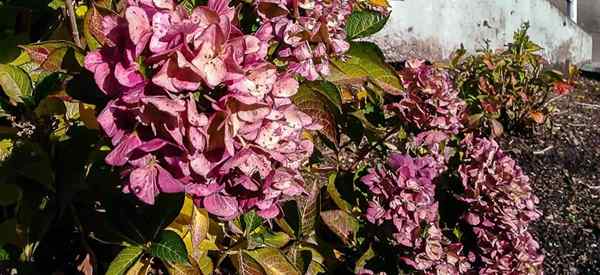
293, 85, 339, 146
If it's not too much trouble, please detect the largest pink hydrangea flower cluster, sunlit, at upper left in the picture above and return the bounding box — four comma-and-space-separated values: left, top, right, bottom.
85, 0, 319, 219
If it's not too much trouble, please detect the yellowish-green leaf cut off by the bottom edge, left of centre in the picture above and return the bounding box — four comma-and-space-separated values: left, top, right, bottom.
247, 248, 300, 275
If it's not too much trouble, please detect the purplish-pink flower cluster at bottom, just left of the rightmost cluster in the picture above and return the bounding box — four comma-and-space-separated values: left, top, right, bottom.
361, 154, 473, 274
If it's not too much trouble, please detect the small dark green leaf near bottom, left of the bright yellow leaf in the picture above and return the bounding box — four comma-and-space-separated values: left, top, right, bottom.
149, 230, 188, 263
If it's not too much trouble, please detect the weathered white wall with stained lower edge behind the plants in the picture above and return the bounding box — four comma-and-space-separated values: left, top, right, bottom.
371, 0, 600, 64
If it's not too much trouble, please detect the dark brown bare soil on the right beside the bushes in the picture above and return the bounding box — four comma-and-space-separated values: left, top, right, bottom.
501, 80, 600, 275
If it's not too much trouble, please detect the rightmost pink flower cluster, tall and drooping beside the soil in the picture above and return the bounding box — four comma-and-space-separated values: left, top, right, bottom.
459, 136, 544, 274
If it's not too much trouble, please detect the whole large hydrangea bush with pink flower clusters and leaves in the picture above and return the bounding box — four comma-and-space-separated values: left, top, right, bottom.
0, 0, 552, 275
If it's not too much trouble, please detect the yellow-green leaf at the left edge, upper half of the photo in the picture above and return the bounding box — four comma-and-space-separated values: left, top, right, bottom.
0, 64, 33, 105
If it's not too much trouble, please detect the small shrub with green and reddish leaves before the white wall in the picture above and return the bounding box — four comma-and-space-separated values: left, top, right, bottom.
449, 24, 576, 136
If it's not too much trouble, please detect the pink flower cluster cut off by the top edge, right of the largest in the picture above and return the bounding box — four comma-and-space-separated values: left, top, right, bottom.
257, 0, 353, 80
